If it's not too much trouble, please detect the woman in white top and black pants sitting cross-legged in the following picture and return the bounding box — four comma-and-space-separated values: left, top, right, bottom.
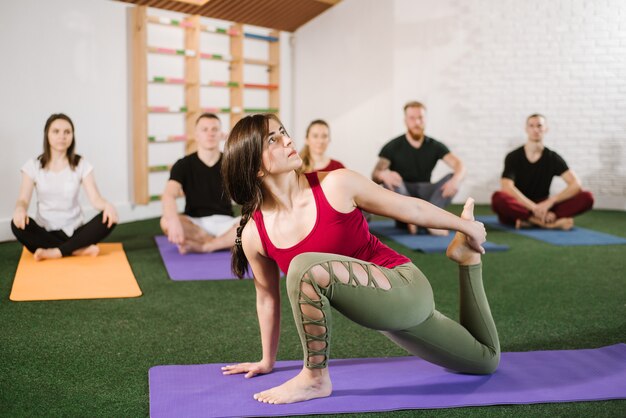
11, 113, 117, 261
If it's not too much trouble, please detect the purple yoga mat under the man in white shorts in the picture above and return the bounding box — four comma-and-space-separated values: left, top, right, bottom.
154, 235, 249, 280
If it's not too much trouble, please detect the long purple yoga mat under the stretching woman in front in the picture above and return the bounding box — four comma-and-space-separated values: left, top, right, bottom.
149, 344, 626, 418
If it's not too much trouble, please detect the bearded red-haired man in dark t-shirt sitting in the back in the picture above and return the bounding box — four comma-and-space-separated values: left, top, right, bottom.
372, 101, 465, 235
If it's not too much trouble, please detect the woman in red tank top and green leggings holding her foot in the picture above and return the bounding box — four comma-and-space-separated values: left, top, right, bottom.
222, 115, 500, 404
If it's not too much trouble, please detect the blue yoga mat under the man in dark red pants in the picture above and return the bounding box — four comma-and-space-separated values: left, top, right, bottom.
476, 215, 626, 246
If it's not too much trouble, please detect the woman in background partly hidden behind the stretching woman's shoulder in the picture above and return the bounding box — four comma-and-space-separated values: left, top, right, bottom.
300, 119, 344, 173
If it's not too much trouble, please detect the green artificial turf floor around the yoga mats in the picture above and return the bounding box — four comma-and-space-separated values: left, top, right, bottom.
0, 206, 626, 417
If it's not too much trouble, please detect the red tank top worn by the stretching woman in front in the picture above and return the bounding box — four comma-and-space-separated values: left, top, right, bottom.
252, 173, 411, 273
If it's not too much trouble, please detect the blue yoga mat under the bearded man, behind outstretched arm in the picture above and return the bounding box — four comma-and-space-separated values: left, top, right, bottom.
369, 220, 509, 254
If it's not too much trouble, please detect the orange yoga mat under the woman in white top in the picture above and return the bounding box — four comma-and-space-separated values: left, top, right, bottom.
9, 243, 141, 301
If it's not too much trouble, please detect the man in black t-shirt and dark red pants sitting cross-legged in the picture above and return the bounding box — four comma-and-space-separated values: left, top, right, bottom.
491, 113, 593, 230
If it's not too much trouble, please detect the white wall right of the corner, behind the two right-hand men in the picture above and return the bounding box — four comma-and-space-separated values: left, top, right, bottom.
294, 0, 626, 209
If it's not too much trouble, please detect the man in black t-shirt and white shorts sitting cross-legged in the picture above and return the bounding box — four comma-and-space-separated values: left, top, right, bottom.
161, 113, 239, 254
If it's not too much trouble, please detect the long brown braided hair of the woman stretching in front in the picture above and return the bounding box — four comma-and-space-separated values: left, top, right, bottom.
222, 113, 282, 279
